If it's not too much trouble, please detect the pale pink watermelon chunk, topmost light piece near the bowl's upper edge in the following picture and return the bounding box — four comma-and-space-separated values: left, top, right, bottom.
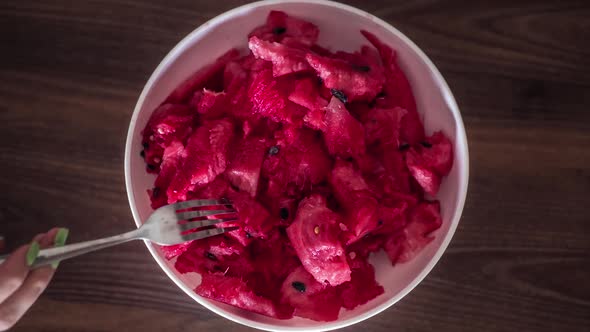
248, 36, 311, 77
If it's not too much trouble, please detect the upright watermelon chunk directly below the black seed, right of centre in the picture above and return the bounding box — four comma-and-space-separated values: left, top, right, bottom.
324, 97, 366, 158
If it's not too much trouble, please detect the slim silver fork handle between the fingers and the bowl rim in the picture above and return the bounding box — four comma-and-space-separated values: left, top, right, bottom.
0, 228, 143, 269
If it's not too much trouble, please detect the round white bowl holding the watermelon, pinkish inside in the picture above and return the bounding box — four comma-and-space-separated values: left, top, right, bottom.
125, 0, 469, 331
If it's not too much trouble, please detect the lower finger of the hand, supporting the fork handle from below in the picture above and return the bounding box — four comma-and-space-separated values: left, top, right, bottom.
0, 230, 57, 329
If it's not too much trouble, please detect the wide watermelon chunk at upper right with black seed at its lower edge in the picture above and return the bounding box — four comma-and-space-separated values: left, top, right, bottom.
305, 53, 385, 101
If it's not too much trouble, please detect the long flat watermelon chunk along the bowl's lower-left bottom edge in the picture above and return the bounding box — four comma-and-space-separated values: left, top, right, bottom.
195, 274, 289, 319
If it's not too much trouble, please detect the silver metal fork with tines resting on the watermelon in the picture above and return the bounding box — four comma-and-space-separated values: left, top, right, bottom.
0, 199, 238, 268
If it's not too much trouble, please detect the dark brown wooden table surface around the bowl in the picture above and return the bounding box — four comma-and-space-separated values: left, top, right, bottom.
0, 0, 590, 332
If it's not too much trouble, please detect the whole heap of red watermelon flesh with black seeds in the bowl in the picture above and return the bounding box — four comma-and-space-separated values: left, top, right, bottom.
142, 11, 453, 321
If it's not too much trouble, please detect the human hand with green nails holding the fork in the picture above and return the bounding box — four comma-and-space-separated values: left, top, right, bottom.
0, 228, 68, 331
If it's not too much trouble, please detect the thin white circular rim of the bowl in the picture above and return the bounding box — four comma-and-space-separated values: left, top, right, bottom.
124, 0, 469, 331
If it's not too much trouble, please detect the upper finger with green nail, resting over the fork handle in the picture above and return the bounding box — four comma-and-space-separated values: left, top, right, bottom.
0, 234, 44, 303
